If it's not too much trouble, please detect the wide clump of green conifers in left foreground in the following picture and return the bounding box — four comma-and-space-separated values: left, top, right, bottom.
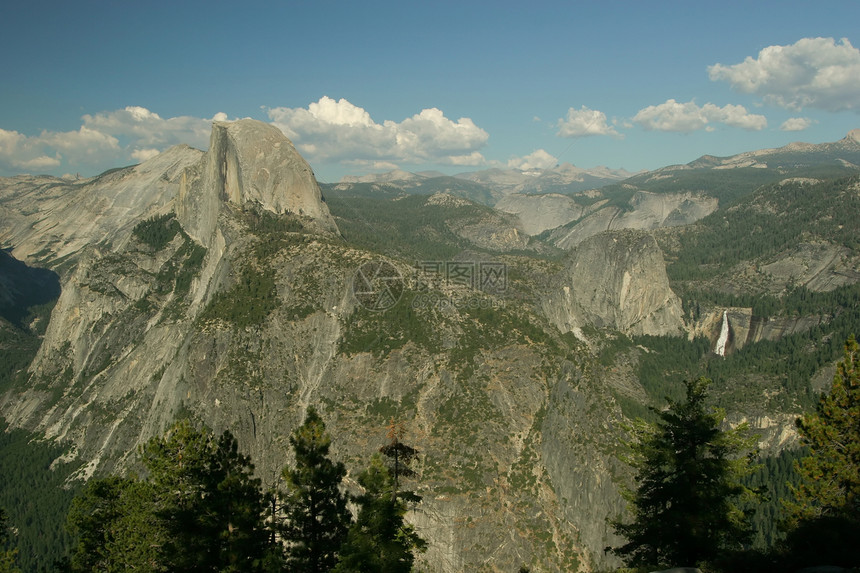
68, 419, 269, 572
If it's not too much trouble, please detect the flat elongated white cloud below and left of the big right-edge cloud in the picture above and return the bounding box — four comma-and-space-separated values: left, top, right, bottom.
633, 99, 767, 133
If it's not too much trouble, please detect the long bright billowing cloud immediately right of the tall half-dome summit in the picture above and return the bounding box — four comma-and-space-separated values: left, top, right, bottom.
268, 96, 489, 165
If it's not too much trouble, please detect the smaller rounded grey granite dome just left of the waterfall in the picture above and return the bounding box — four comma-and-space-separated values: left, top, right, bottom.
544, 230, 683, 335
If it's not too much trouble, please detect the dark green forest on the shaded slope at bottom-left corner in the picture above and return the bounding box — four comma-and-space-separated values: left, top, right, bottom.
0, 422, 81, 571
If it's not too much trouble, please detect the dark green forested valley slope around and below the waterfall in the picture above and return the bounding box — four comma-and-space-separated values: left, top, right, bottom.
620, 284, 860, 418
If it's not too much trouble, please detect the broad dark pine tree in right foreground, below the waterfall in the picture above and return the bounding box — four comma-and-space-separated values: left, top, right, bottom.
614, 378, 752, 567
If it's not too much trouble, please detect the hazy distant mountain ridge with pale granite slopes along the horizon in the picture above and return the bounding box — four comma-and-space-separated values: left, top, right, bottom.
333, 129, 860, 242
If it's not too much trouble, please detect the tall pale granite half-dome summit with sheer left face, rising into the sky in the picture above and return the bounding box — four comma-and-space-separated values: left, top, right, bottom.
176, 119, 337, 245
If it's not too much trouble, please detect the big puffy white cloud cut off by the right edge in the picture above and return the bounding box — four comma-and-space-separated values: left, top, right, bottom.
708, 38, 860, 111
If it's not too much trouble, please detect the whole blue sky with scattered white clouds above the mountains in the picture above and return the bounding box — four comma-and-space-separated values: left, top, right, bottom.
0, 0, 860, 182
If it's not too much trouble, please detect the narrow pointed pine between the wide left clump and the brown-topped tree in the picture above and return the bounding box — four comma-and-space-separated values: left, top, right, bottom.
282, 406, 352, 573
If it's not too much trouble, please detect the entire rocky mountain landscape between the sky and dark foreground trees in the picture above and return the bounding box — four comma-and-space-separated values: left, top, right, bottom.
0, 120, 860, 573
